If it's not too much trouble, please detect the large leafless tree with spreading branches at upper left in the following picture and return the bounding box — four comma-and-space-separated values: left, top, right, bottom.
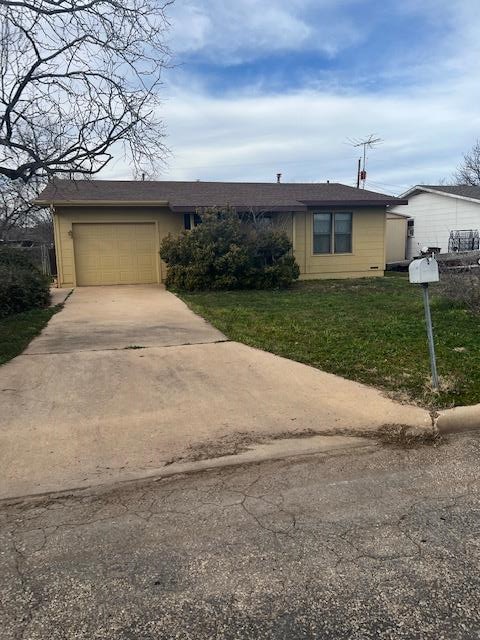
0, 0, 172, 185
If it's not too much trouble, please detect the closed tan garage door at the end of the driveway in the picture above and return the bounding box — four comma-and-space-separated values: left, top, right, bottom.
73, 223, 157, 286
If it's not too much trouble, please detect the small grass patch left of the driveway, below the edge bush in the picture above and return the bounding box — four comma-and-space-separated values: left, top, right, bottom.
0, 305, 62, 365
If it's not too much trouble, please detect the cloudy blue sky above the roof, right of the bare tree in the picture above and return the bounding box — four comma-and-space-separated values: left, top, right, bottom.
100, 0, 480, 194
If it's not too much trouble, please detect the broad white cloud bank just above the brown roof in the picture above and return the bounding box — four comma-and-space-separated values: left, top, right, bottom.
142, 74, 480, 191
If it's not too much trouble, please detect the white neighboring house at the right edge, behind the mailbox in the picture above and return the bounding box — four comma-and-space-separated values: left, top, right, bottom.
387, 185, 480, 262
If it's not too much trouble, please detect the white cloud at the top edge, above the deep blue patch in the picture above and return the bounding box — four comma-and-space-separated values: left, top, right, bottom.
170, 0, 362, 65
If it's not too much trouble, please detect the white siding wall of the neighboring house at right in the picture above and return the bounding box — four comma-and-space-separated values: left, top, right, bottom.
391, 192, 480, 259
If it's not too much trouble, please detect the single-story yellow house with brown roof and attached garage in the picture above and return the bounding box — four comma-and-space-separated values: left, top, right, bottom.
38, 180, 407, 286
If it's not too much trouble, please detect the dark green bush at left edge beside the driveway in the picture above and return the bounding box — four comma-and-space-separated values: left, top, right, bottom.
0, 247, 50, 318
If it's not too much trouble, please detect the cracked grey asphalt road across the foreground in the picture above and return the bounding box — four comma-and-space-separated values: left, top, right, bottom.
0, 434, 480, 640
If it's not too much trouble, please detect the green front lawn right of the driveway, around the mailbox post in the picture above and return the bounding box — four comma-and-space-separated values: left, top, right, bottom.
181, 275, 480, 408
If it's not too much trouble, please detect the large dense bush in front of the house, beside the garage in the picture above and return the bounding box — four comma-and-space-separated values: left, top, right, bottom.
160, 209, 300, 291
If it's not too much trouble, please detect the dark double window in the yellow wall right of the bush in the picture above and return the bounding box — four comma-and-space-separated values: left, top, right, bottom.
313, 211, 352, 254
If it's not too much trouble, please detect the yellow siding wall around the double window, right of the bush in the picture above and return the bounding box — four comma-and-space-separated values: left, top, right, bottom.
294, 209, 385, 280
